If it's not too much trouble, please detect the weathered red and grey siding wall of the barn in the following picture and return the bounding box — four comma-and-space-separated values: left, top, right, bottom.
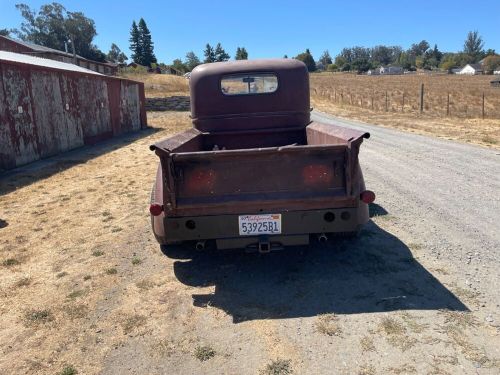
0, 60, 147, 170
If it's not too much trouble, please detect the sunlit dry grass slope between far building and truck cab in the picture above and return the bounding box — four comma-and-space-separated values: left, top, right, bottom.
118, 72, 189, 98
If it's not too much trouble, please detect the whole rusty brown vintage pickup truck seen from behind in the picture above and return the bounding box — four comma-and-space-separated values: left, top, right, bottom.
150, 59, 375, 252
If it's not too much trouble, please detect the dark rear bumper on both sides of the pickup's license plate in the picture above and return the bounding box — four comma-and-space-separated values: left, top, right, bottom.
153, 203, 368, 243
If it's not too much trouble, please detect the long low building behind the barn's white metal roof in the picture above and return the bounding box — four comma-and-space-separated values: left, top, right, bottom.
0, 36, 118, 75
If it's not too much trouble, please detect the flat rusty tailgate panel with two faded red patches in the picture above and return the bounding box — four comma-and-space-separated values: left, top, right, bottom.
169, 145, 349, 213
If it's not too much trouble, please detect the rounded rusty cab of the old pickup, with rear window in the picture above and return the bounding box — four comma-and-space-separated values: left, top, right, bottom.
190, 59, 310, 132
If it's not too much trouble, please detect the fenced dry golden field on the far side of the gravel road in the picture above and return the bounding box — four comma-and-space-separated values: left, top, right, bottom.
311, 73, 500, 148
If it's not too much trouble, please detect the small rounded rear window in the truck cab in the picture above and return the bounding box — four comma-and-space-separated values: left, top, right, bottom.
220, 73, 278, 96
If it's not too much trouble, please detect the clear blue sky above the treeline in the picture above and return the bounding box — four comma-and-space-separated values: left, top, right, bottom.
0, 0, 500, 63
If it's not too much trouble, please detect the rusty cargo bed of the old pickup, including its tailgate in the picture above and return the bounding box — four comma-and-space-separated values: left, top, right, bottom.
151, 122, 369, 217
